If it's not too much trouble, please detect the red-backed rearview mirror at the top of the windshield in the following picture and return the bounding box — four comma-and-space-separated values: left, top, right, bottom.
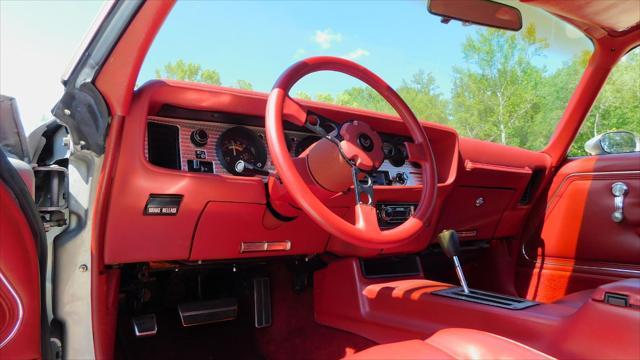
428, 0, 522, 31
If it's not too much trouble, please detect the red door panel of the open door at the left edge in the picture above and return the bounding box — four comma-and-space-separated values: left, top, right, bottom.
0, 182, 40, 359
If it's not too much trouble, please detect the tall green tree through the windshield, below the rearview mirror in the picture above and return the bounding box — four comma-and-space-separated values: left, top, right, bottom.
451, 24, 548, 148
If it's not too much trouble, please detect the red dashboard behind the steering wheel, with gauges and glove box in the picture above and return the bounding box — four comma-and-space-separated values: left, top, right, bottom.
104, 81, 549, 264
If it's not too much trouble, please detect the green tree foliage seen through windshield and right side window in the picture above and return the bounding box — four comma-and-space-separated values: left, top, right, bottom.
156, 32, 640, 156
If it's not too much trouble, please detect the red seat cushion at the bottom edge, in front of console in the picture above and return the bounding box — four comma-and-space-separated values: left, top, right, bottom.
347, 328, 553, 360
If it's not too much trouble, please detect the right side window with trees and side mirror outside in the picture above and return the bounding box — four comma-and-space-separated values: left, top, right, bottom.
569, 48, 640, 156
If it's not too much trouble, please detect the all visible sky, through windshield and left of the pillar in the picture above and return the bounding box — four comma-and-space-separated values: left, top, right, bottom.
0, 0, 590, 132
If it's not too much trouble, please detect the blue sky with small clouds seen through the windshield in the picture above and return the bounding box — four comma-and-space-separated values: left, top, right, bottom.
138, 1, 591, 96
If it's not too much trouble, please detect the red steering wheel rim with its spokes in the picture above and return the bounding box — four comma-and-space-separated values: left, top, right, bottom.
266, 56, 437, 249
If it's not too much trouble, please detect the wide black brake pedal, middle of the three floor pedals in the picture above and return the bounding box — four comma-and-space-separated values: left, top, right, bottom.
178, 298, 238, 327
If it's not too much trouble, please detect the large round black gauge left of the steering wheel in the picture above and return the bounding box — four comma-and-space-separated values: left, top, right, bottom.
216, 126, 267, 176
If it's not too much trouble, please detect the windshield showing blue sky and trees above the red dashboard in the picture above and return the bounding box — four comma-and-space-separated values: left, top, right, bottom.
138, 1, 592, 150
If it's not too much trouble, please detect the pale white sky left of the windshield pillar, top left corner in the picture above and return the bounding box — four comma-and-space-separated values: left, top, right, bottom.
0, 0, 103, 133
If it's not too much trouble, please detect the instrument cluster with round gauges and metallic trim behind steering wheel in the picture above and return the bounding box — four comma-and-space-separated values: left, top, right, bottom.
145, 116, 422, 186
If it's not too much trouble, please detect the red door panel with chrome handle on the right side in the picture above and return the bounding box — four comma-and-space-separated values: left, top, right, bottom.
519, 153, 640, 301
